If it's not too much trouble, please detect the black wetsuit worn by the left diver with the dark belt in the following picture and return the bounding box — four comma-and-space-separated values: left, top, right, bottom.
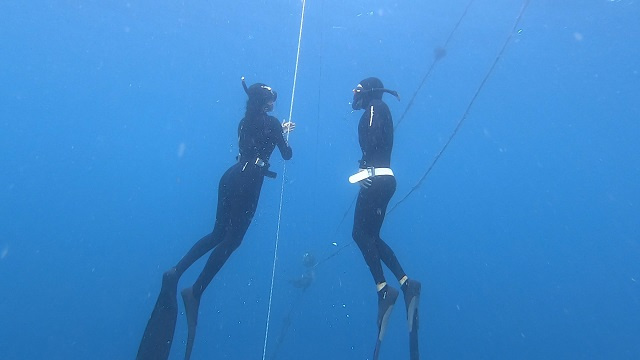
170, 113, 292, 298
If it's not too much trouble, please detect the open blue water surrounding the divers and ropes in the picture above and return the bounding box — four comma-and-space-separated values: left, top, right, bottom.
0, 0, 640, 360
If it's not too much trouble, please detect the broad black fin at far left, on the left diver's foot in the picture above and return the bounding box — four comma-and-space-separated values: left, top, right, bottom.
136, 272, 178, 360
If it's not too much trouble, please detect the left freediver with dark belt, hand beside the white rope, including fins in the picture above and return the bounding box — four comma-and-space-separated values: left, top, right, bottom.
136, 78, 295, 360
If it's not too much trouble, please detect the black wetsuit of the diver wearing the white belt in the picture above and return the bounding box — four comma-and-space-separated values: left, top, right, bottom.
352, 99, 405, 284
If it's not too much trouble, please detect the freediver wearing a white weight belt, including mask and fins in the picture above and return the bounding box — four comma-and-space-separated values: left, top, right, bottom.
349, 77, 421, 360
